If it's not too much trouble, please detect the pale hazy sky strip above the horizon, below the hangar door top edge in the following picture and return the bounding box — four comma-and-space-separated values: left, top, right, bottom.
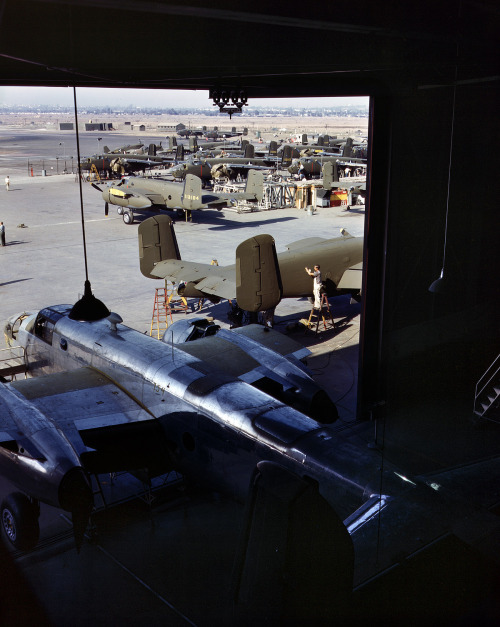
0, 86, 368, 108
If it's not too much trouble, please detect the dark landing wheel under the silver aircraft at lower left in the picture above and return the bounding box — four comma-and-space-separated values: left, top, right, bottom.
1, 492, 40, 551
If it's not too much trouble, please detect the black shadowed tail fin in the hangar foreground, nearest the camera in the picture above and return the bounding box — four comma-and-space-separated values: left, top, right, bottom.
233, 461, 354, 625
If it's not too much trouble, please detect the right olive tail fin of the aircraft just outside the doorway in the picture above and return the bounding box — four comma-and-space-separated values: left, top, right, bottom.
236, 235, 283, 312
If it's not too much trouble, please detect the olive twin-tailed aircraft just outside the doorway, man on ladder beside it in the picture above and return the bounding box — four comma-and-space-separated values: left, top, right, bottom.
138, 216, 363, 311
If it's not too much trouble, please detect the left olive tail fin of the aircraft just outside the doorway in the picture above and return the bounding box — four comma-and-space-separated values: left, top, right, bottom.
138, 215, 181, 279
